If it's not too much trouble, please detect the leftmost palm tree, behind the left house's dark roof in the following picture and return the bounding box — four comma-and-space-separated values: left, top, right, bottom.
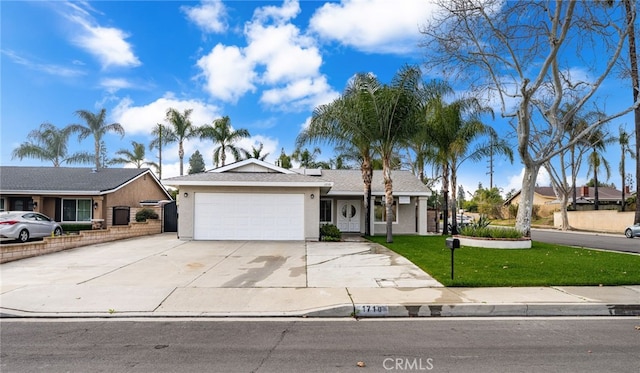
11, 123, 93, 167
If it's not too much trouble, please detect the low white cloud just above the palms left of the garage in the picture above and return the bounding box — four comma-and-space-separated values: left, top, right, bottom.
112, 93, 220, 135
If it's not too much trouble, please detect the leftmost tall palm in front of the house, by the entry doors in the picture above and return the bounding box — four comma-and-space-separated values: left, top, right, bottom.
296, 73, 377, 236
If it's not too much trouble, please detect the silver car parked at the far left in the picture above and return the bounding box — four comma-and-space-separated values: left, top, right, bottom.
0, 211, 62, 242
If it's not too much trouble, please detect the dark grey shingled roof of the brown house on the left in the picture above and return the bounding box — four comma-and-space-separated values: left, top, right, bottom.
0, 166, 171, 199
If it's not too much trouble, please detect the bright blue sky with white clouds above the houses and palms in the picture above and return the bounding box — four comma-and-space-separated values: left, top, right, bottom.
0, 0, 633, 196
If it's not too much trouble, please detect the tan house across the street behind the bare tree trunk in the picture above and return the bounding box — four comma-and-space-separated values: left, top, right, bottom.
504, 186, 631, 212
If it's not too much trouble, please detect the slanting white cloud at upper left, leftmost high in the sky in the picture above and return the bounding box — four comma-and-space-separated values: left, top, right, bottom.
65, 2, 141, 68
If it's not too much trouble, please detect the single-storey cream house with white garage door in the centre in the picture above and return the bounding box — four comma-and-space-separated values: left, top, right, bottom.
163, 159, 431, 240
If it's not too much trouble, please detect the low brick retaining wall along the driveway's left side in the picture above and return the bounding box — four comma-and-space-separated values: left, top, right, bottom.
0, 220, 162, 263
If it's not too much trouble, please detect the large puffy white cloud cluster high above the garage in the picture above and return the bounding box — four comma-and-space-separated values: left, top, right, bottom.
197, 0, 338, 111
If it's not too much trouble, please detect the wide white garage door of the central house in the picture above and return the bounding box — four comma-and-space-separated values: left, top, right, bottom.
193, 193, 304, 240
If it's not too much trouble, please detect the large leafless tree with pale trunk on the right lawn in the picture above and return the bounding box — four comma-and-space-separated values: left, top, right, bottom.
421, 0, 640, 236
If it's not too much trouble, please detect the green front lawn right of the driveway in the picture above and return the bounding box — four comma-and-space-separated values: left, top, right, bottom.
369, 236, 640, 287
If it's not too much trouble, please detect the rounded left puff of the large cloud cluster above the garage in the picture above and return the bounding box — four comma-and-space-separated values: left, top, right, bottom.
197, 44, 256, 102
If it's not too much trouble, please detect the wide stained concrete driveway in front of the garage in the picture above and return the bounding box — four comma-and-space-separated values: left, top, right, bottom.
0, 233, 442, 315
